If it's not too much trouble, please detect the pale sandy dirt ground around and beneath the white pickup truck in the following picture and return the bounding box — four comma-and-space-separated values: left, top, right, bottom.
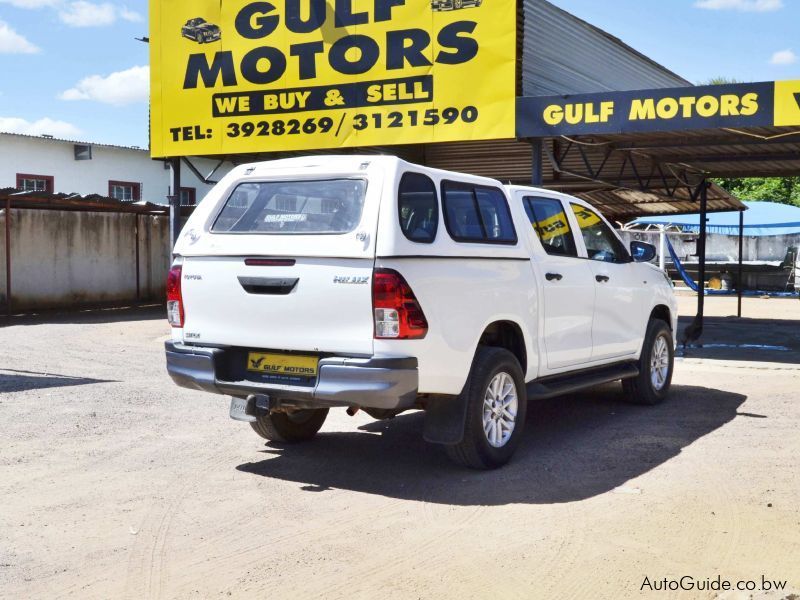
0, 297, 800, 600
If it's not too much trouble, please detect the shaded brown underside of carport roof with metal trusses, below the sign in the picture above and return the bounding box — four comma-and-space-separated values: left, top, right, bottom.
524, 127, 800, 221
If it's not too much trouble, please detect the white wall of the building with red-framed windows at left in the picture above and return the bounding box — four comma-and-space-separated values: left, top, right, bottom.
0, 133, 231, 204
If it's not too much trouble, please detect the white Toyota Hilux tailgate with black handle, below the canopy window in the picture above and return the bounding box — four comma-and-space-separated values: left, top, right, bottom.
182, 256, 374, 355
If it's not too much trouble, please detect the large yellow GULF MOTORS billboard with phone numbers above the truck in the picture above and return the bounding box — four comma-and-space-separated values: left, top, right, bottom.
150, 0, 516, 157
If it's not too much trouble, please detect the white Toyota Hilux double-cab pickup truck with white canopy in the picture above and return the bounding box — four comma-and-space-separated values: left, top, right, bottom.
166, 156, 677, 469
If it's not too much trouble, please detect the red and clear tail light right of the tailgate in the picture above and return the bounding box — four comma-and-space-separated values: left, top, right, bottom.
372, 269, 428, 340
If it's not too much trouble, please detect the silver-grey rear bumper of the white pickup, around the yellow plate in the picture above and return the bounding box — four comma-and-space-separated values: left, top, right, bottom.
164, 341, 419, 410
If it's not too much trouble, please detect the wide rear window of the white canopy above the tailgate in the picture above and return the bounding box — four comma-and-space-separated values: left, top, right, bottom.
211, 179, 367, 234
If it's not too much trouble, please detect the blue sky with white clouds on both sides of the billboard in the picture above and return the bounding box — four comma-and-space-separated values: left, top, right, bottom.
0, 0, 800, 148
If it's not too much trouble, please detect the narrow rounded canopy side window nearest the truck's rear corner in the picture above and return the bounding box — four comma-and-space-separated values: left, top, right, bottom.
397, 173, 439, 244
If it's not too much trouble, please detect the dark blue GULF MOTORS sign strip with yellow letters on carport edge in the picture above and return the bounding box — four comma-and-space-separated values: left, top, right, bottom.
517, 81, 800, 138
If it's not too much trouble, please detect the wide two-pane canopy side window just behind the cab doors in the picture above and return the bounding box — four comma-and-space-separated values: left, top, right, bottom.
442, 181, 517, 244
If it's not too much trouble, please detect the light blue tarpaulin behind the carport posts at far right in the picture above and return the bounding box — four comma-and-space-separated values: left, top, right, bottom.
634, 202, 800, 236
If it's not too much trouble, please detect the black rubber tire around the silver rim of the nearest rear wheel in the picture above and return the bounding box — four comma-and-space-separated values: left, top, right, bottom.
446, 346, 528, 470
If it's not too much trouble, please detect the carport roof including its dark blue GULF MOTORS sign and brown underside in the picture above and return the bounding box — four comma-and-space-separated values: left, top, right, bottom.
517, 81, 800, 221
